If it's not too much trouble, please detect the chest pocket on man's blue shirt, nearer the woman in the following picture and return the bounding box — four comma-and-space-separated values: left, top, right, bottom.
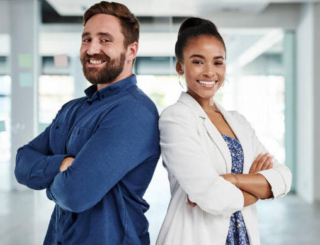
67, 127, 93, 156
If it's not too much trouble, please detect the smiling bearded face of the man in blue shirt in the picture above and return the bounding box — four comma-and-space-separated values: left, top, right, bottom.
80, 14, 126, 84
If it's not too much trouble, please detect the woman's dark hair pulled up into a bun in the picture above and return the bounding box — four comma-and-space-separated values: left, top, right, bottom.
175, 17, 226, 62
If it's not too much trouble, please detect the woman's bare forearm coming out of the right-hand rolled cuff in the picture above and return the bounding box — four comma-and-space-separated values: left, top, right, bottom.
236, 174, 273, 199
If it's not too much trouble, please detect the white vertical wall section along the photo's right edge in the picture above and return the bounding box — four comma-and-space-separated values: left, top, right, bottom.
296, 3, 320, 202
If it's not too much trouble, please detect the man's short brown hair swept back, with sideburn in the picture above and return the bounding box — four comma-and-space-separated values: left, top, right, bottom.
83, 1, 140, 48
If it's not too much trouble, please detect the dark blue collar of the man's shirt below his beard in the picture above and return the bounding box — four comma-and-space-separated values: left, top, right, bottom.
84, 75, 137, 102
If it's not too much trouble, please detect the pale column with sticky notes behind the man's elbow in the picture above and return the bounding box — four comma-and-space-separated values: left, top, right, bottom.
9, 0, 40, 189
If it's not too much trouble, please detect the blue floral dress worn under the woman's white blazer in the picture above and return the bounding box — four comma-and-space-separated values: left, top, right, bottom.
222, 134, 250, 245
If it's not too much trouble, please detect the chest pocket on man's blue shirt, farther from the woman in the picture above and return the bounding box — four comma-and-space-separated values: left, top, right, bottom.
49, 123, 68, 155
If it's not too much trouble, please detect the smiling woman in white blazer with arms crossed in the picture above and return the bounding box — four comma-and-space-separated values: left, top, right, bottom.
157, 18, 291, 245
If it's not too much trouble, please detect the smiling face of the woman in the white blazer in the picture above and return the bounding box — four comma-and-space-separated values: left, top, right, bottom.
176, 36, 226, 101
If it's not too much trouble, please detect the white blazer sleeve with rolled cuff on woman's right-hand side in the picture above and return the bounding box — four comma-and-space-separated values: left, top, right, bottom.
239, 111, 292, 199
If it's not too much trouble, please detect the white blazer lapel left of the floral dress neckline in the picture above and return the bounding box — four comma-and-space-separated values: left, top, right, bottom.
178, 92, 232, 173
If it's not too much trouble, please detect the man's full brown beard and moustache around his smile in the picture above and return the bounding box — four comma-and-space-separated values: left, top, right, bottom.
81, 52, 126, 85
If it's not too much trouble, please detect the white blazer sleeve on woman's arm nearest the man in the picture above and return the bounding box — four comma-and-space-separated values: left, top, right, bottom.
159, 104, 244, 215
